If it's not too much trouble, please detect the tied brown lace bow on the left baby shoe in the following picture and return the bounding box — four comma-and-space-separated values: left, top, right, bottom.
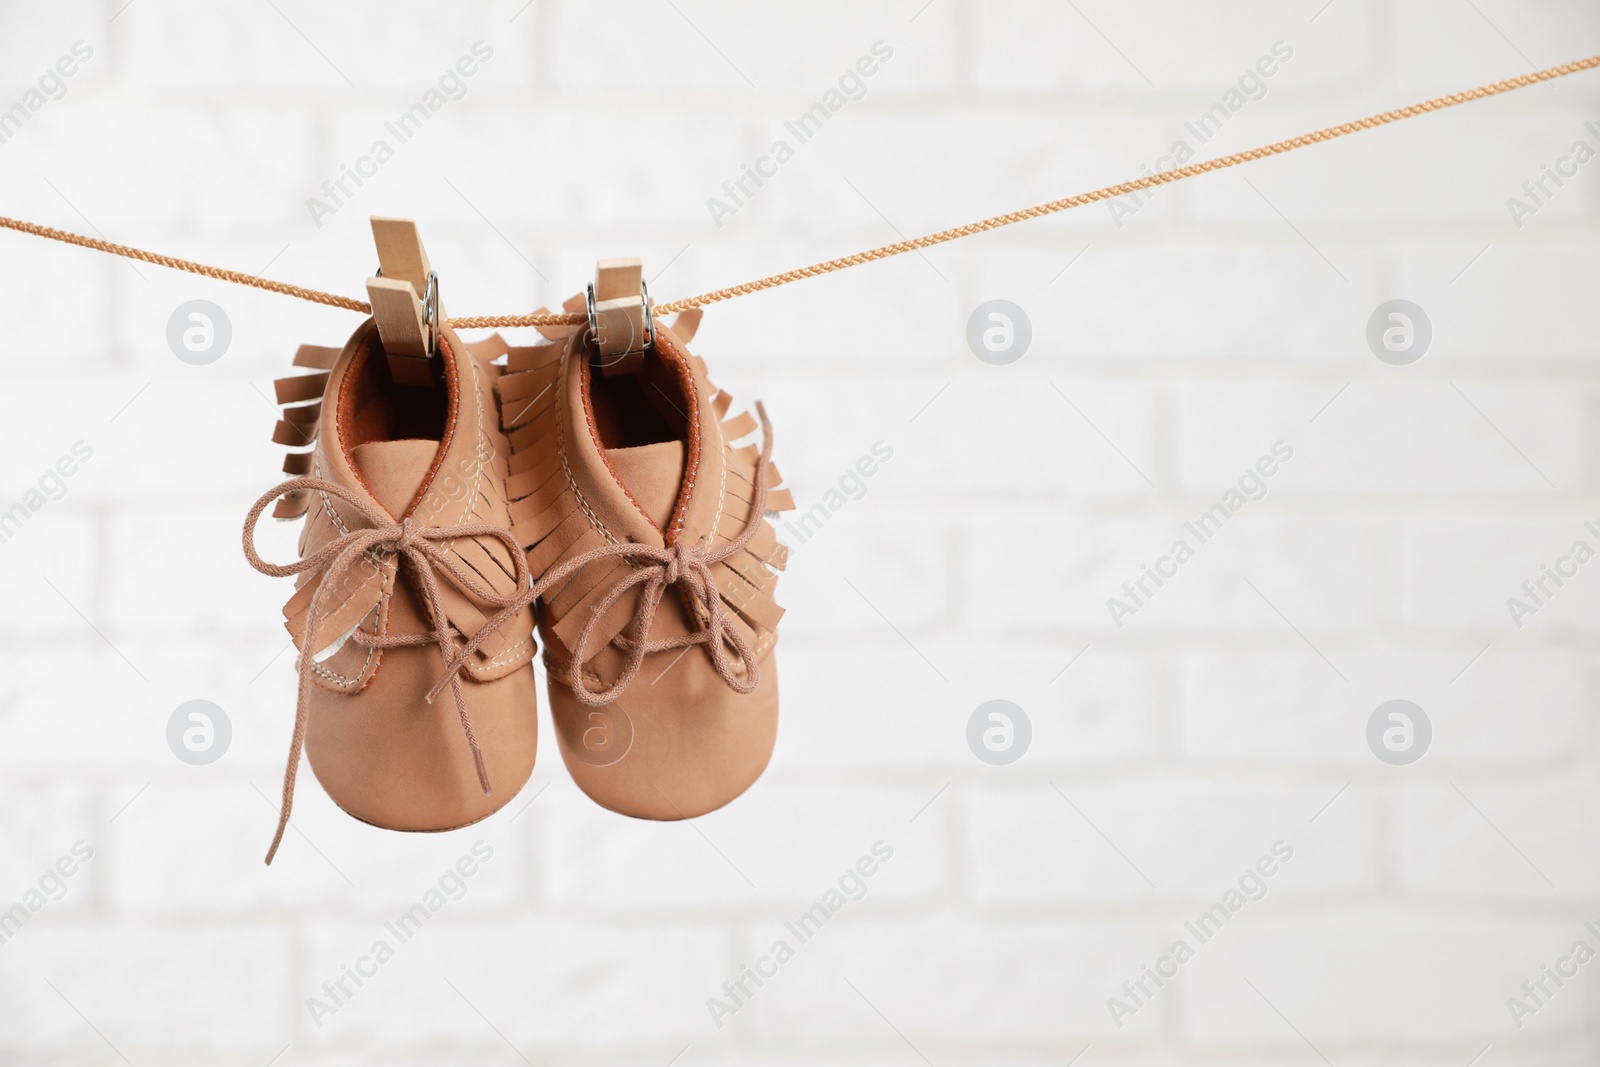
243, 478, 530, 864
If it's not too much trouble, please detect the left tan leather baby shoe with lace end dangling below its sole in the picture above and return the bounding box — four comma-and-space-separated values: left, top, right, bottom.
245, 320, 538, 862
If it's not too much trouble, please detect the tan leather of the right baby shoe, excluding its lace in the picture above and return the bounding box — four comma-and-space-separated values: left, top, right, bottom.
499, 298, 787, 819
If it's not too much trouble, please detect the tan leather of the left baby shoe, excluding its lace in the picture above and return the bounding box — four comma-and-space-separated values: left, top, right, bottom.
265, 320, 538, 830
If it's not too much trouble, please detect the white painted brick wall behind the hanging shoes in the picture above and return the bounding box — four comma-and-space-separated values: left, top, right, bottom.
0, 0, 1600, 1067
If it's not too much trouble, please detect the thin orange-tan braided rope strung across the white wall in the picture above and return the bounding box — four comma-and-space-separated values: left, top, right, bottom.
0, 56, 1600, 330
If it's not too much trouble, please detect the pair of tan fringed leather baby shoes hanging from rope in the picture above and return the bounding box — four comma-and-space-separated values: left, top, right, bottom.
245, 238, 794, 862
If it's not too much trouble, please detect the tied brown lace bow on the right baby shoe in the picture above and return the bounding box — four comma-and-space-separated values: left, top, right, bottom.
429, 402, 773, 707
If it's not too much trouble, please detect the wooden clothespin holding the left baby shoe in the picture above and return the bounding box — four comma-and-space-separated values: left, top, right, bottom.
366, 216, 443, 386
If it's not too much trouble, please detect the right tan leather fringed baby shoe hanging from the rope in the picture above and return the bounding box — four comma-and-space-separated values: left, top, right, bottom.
457, 298, 794, 819
